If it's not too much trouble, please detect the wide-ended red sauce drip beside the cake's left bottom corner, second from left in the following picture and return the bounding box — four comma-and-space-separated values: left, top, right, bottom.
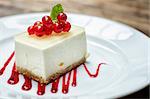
7, 63, 19, 85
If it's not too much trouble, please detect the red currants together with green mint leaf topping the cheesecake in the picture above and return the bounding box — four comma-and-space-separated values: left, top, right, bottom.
27, 4, 71, 37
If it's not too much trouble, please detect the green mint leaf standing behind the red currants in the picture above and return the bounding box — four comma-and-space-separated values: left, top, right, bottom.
50, 4, 64, 21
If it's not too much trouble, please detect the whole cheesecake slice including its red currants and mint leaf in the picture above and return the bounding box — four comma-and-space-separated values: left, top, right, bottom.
15, 4, 87, 84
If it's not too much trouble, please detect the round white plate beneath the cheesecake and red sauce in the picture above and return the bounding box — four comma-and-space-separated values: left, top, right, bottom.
0, 13, 150, 99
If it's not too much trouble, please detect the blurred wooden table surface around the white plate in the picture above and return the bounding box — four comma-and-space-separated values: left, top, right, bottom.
0, 0, 150, 98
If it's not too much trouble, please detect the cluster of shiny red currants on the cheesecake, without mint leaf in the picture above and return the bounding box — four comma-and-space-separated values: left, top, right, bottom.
28, 13, 71, 37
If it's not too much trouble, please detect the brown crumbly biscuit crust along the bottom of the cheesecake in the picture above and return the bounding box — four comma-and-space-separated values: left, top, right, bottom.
16, 57, 86, 84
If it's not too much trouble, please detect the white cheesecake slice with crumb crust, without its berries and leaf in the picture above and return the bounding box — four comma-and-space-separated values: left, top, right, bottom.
15, 25, 87, 84
